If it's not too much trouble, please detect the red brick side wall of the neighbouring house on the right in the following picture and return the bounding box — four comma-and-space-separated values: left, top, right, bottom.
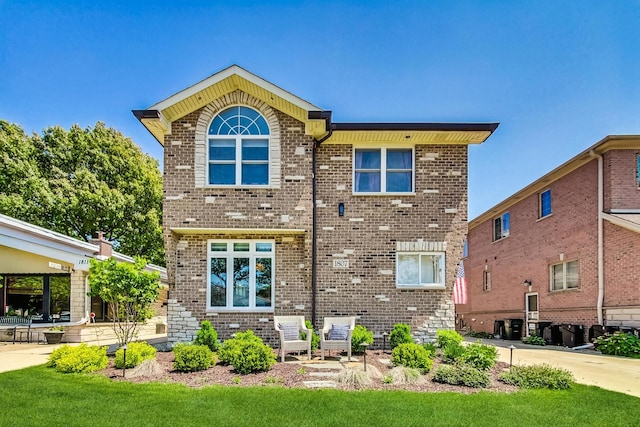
456, 160, 598, 332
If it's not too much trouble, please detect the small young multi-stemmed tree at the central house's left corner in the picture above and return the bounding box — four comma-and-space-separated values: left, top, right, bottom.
89, 258, 160, 346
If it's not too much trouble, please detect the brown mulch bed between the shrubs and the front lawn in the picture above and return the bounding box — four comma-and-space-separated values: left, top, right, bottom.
102, 350, 518, 393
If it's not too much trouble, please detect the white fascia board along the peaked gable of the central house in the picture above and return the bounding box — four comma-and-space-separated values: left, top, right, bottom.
147, 65, 322, 111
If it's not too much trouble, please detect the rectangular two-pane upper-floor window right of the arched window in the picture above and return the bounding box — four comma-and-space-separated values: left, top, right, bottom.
353, 148, 414, 194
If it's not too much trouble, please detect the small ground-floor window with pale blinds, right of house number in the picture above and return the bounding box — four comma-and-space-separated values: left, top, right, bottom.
396, 252, 445, 289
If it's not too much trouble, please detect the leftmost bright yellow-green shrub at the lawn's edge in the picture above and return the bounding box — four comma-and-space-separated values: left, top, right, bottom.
47, 344, 109, 373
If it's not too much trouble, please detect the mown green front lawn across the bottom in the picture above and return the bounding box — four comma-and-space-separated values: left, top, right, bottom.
0, 366, 640, 427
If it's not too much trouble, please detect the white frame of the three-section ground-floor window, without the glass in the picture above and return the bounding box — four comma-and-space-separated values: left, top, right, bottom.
206, 239, 276, 313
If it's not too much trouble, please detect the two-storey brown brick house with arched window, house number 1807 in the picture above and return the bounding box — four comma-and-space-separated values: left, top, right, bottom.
134, 65, 498, 344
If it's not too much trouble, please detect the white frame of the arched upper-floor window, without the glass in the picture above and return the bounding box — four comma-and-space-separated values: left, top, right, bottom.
205, 105, 271, 188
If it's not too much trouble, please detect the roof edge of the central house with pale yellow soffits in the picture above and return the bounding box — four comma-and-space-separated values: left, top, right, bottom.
133, 65, 498, 145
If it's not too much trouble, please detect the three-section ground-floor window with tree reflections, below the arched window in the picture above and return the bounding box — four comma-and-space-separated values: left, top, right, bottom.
207, 240, 275, 311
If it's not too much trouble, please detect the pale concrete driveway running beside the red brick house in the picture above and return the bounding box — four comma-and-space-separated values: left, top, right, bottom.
467, 339, 640, 397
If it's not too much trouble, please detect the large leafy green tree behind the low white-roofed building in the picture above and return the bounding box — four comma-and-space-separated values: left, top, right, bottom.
0, 120, 164, 265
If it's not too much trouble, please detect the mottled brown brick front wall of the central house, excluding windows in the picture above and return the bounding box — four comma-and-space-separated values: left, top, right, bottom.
164, 94, 467, 344
